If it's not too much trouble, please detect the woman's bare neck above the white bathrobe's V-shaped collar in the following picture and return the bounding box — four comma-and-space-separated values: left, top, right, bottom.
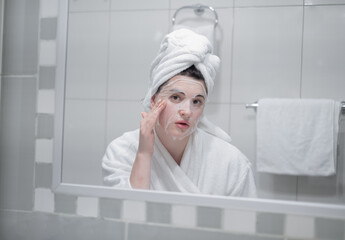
156, 130, 189, 165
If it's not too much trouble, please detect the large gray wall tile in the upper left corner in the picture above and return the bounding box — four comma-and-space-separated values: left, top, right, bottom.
2, 0, 40, 75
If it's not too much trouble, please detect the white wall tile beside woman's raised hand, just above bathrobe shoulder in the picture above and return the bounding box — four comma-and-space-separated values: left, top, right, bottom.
106, 101, 143, 144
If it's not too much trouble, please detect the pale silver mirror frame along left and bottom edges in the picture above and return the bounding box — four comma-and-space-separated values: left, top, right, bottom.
52, 0, 345, 219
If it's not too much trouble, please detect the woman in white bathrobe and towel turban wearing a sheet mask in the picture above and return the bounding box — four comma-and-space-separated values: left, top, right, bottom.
102, 29, 256, 197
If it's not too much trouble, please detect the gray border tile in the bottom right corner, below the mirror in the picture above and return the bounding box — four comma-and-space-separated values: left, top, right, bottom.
315, 218, 345, 240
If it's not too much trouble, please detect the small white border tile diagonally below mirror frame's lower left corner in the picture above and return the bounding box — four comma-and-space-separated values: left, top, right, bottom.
34, 188, 54, 213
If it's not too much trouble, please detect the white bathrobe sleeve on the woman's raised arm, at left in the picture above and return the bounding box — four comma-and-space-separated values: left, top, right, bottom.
102, 129, 139, 188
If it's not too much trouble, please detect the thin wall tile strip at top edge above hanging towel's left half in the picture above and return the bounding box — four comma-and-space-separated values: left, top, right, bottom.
235, 0, 303, 7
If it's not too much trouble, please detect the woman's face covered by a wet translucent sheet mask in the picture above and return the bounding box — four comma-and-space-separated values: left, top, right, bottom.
152, 75, 207, 140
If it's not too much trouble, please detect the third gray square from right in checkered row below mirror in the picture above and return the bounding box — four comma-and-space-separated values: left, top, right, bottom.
197, 207, 222, 228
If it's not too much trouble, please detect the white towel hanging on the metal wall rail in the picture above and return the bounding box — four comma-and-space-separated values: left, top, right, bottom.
256, 99, 340, 176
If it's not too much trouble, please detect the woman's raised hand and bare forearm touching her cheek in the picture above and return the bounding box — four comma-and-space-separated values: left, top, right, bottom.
129, 99, 166, 189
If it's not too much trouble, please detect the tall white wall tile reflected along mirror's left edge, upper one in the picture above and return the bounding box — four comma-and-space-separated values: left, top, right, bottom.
66, 12, 109, 99
